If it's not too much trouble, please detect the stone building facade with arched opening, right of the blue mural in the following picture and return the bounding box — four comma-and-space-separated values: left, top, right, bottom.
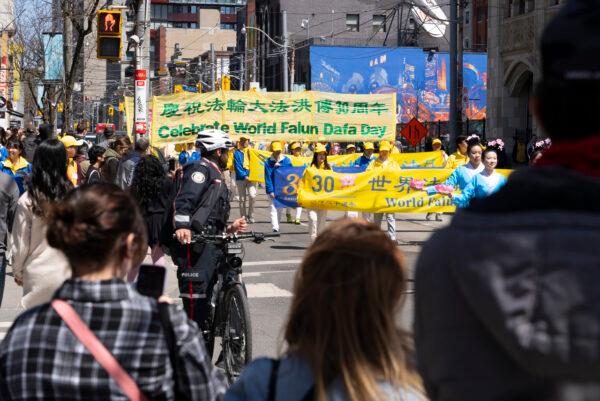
487, 0, 563, 161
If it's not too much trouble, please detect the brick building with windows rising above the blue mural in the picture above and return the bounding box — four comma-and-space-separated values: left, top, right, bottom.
246, 0, 450, 90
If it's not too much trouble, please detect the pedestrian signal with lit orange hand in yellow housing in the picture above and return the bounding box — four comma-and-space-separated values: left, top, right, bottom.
96, 10, 122, 60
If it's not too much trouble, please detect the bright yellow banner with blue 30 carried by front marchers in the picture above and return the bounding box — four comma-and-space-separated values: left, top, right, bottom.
298, 167, 511, 213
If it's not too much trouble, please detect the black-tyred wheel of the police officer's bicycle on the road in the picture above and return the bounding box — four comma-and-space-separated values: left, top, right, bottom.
223, 284, 252, 383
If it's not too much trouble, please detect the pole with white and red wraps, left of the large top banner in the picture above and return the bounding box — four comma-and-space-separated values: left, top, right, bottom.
133, 0, 148, 139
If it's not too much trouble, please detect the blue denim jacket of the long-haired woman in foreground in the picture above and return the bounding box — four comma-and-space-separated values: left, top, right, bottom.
225, 357, 422, 401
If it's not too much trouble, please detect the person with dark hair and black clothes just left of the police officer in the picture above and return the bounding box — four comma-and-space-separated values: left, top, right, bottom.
130, 156, 173, 268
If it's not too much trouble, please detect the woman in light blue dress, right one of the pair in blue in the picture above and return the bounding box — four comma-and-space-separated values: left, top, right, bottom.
450, 146, 506, 207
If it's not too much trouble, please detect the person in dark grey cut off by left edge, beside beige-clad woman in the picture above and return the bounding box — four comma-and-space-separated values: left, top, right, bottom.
0, 172, 19, 305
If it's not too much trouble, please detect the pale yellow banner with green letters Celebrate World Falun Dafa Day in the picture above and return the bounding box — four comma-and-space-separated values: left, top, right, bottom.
152, 91, 396, 145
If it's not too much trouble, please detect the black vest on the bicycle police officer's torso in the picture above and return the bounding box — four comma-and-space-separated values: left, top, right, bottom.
191, 160, 230, 234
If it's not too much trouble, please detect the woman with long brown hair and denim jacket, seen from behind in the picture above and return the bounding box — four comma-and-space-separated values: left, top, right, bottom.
225, 219, 424, 401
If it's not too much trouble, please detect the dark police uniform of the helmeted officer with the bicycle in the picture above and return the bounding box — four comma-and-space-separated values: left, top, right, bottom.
172, 159, 229, 331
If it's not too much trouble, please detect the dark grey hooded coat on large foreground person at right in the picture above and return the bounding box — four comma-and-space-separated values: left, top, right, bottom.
414, 167, 600, 401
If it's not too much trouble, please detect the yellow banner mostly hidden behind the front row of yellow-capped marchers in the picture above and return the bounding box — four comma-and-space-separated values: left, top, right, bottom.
244, 149, 444, 182
